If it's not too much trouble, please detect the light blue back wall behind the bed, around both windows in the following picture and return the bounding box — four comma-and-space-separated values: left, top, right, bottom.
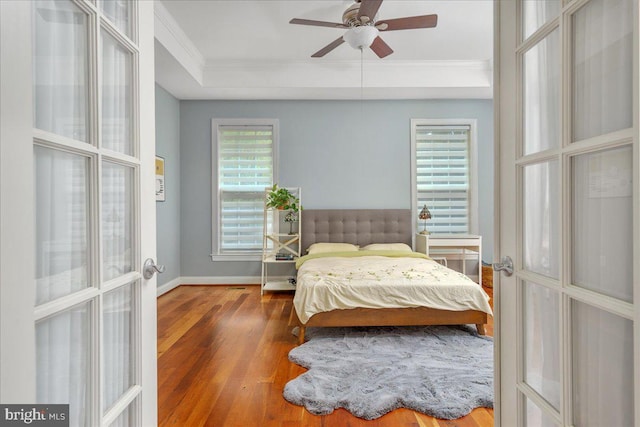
180, 100, 493, 276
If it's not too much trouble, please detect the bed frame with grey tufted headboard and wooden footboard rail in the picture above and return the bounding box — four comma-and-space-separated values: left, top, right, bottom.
291, 209, 488, 344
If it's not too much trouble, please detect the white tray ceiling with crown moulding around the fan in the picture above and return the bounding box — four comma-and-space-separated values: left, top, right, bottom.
155, 0, 493, 99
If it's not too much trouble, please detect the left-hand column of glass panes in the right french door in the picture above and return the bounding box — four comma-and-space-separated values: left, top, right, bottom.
518, 2, 562, 426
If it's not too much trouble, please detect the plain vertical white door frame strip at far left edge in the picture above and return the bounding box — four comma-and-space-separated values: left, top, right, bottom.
0, 1, 36, 404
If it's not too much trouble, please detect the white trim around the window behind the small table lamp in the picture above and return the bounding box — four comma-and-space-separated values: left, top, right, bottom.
411, 119, 479, 235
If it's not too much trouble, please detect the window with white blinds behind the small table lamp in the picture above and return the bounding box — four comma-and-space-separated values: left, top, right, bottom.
411, 119, 478, 234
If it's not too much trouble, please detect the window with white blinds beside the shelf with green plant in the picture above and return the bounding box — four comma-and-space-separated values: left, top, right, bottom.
212, 119, 278, 259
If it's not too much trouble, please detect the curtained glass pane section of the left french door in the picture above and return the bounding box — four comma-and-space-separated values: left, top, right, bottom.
32, 0, 142, 426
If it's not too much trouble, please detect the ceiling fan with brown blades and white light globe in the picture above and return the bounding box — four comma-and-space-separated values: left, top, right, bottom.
289, 0, 438, 58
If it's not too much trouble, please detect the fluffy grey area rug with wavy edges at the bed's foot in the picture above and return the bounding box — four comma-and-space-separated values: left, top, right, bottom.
283, 325, 493, 420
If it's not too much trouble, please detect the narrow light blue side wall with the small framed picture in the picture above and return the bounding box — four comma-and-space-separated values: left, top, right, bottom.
156, 85, 181, 286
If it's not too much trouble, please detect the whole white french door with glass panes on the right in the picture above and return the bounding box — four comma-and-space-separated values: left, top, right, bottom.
496, 0, 640, 427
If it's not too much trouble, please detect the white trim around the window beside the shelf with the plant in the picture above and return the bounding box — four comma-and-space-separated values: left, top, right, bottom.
209, 119, 280, 261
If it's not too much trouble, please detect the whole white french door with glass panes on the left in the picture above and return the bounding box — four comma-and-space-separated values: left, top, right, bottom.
0, 0, 157, 426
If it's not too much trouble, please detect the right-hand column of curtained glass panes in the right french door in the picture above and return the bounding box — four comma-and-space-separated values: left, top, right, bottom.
565, 0, 638, 426
